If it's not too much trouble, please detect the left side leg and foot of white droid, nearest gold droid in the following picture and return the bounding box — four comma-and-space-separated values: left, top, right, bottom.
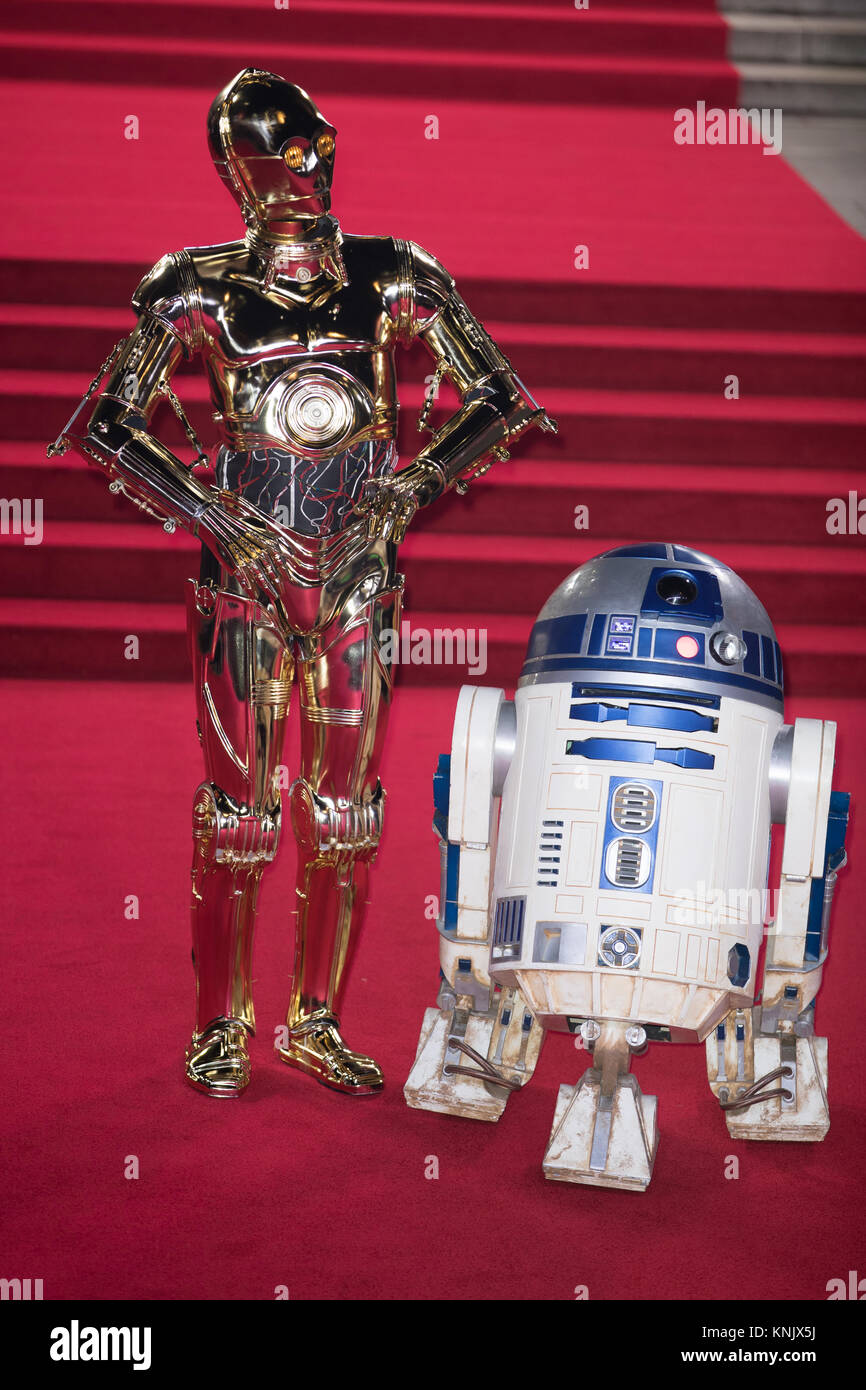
403, 685, 544, 1120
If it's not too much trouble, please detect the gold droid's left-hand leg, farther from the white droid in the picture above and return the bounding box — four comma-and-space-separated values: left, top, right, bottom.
186, 562, 292, 1097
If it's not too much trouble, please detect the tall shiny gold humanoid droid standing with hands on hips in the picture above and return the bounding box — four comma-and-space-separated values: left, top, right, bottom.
50, 68, 555, 1095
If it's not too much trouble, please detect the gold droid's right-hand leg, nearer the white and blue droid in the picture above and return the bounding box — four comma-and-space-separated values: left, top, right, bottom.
278, 588, 402, 1095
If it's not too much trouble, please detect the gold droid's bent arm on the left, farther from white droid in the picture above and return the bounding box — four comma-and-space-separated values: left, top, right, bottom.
49, 253, 287, 598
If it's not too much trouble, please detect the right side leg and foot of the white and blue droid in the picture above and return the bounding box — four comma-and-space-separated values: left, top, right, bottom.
706, 719, 849, 1141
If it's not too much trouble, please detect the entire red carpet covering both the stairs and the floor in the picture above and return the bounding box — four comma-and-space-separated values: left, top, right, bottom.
0, 0, 866, 1300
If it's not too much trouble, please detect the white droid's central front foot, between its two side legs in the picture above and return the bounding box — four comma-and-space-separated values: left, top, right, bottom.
544, 1068, 659, 1193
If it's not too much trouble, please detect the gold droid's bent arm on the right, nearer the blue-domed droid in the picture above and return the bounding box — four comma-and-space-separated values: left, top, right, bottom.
357, 242, 556, 541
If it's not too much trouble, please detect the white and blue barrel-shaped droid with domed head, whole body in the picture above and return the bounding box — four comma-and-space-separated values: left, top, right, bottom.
405, 543, 848, 1191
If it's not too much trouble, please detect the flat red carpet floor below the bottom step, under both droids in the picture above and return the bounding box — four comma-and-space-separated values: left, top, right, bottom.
0, 681, 866, 1301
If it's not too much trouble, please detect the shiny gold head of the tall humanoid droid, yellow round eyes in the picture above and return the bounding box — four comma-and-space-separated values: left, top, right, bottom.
207, 68, 336, 232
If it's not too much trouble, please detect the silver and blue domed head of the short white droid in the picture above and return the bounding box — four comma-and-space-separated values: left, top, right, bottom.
520, 543, 783, 710
